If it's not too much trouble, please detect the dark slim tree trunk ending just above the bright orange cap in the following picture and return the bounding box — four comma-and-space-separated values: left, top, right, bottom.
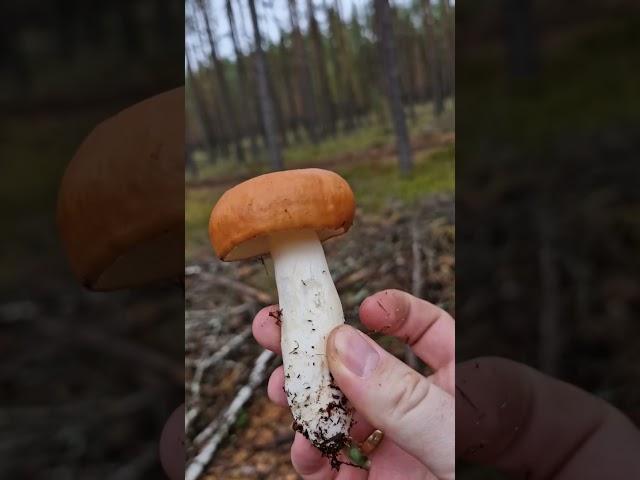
248, 0, 284, 170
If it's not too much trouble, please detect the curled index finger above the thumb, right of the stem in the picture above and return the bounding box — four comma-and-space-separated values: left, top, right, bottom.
360, 290, 455, 370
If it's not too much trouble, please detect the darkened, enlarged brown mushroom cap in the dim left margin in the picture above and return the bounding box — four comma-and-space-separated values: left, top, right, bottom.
58, 87, 184, 290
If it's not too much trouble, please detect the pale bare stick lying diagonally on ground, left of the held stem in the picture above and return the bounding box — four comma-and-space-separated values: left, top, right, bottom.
184, 350, 274, 480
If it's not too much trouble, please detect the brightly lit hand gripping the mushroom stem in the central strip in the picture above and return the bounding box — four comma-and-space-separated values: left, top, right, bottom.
253, 290, 455, 480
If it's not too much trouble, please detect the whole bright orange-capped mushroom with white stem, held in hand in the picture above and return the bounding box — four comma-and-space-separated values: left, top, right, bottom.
209, 169, 355, 458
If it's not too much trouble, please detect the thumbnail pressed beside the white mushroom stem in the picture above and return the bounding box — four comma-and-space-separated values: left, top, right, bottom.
333, 327, 380, 378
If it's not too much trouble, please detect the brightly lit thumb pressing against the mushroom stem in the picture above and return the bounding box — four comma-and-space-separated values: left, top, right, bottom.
327, 325, 455, 479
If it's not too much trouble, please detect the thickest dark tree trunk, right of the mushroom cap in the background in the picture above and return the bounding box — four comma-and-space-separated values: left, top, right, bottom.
374, 0, 413, 175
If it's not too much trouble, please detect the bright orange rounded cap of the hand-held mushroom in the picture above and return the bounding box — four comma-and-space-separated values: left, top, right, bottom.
209, 168, 355, 261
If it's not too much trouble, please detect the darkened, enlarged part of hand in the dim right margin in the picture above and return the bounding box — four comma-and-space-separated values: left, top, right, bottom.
456, 358, 640, 480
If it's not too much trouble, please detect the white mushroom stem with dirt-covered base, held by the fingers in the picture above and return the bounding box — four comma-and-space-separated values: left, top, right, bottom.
270, 230, 351, 454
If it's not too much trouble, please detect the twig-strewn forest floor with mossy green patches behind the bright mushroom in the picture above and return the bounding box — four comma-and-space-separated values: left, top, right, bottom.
185, 104, 455, 480
